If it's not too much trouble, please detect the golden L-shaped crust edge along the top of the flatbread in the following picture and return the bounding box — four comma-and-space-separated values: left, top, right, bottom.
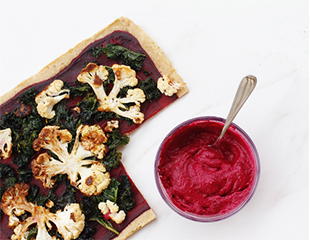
0, 17, 189, 105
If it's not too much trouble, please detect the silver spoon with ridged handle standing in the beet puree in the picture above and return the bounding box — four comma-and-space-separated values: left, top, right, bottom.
209, 75, 257, 147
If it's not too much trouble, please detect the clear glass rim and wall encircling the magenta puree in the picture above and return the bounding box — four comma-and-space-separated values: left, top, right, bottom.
154, 116, 261, 222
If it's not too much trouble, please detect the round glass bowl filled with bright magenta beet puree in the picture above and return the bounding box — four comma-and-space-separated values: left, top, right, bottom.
155, 117, 260, 222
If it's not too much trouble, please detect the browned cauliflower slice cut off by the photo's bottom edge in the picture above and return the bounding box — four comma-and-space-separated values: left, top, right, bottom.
1, 183, 85, 240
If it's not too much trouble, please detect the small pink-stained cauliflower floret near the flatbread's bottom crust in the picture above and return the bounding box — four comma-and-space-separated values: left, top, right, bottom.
98, 200, 126, 224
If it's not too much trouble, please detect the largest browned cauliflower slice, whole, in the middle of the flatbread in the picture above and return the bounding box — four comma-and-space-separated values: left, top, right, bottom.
31, 125, 111, 196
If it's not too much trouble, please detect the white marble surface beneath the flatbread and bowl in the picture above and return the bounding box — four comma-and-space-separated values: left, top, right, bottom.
0, 0, 309, 240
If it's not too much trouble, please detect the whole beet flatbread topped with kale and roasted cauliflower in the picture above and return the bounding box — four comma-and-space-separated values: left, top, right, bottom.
0, 17, 188, 240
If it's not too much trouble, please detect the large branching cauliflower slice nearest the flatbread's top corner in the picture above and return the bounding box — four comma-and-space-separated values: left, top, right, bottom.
77, 63, 145, 124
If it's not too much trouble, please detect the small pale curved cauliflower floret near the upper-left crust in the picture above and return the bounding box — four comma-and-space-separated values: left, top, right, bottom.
35, 79, 70, 119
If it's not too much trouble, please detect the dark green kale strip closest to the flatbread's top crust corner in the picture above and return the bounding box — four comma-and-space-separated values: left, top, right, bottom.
90, 44, 146, 71
